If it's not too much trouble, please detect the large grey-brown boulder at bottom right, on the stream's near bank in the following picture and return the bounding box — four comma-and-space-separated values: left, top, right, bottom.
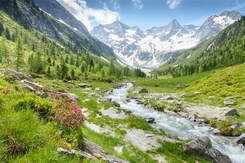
183, 136, 232, 163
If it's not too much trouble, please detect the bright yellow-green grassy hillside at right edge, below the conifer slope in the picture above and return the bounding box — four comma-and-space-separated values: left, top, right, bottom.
186, 64, 245, 105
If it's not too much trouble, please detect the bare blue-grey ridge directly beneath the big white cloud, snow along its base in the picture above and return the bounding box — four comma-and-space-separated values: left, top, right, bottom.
34, 0, 89, 35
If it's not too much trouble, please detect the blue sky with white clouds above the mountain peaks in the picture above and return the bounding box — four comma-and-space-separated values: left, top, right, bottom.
58, 0, 245, 30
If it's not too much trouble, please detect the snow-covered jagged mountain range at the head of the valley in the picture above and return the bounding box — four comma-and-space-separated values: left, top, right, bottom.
91, 11, 241, 69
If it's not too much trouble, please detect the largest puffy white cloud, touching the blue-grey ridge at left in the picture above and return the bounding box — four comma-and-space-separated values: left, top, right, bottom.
58, 0, 120, 31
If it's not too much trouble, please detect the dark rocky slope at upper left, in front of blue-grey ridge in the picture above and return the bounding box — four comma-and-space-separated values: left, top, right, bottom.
0, 0, 115, 58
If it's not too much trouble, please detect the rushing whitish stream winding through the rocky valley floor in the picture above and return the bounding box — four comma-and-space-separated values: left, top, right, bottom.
108, 83, 245, 163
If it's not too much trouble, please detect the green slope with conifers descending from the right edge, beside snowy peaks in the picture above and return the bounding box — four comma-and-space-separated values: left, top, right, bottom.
156, 16, 245, 76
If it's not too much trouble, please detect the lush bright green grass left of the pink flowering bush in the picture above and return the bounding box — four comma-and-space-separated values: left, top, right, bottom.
0, 78, 83, 162
